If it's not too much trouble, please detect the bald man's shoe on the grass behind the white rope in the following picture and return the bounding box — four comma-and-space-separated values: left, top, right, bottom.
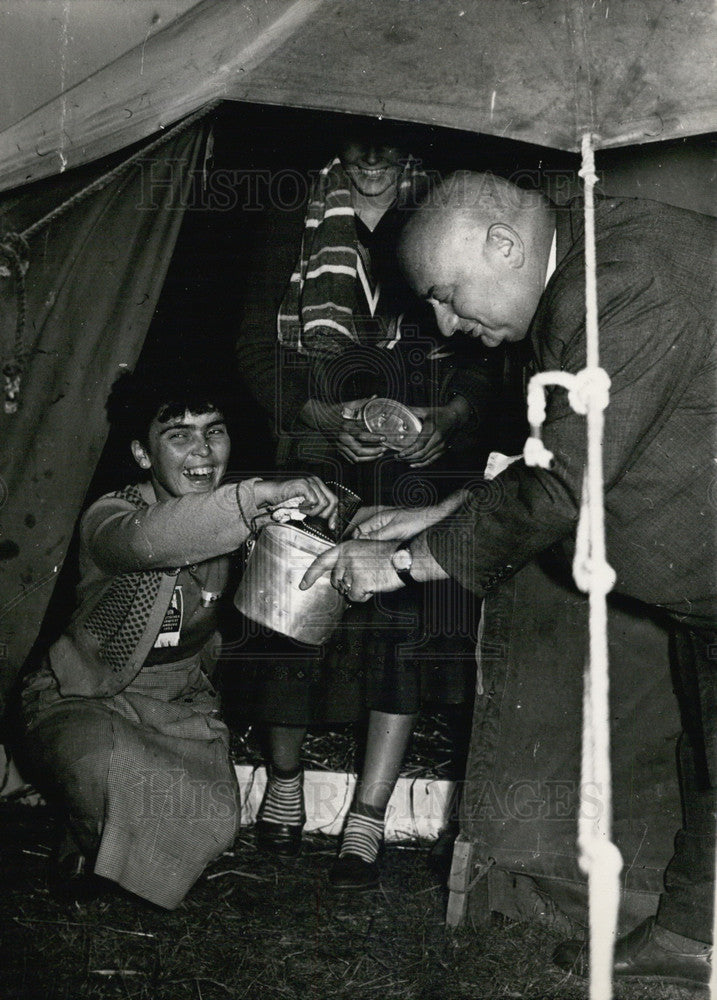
553, 917, 711, 985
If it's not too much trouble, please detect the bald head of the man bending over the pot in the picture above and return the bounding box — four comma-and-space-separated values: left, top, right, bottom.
399, 171, 555, 346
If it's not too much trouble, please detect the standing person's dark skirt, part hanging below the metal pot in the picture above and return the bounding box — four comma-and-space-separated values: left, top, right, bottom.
221, 581, 480, 726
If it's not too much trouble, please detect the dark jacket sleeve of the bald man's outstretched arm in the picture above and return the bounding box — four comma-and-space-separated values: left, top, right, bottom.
428, 262, 704, 594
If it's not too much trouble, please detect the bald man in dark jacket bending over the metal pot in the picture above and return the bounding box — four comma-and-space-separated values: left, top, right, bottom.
304, 172, 717, 983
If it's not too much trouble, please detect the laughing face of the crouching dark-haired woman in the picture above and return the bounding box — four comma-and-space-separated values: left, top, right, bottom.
132, 410, 230, 500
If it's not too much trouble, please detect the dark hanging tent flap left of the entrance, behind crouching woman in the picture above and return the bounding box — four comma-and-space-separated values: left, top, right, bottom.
0, 126, 204, 712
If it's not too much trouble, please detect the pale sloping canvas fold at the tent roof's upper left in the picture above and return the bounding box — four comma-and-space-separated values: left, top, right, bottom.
0, 0, 321, 190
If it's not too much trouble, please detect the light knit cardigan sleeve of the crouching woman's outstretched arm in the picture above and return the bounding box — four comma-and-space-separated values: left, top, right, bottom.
80, 480, 257, 573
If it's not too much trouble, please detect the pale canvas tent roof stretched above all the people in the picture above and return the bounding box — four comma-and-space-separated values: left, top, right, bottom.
0, 0, 717, 188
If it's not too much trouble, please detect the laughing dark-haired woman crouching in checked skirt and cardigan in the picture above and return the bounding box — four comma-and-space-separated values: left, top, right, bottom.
22, 369, 336, 909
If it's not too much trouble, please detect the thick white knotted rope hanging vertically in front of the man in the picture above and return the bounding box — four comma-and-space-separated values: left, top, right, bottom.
523, 133, 620, 1000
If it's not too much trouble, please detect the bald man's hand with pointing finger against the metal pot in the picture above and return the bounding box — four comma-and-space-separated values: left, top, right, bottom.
299, 541, 403, 602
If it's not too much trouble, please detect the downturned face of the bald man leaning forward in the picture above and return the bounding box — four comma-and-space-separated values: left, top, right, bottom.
401, 217, 542, 347
